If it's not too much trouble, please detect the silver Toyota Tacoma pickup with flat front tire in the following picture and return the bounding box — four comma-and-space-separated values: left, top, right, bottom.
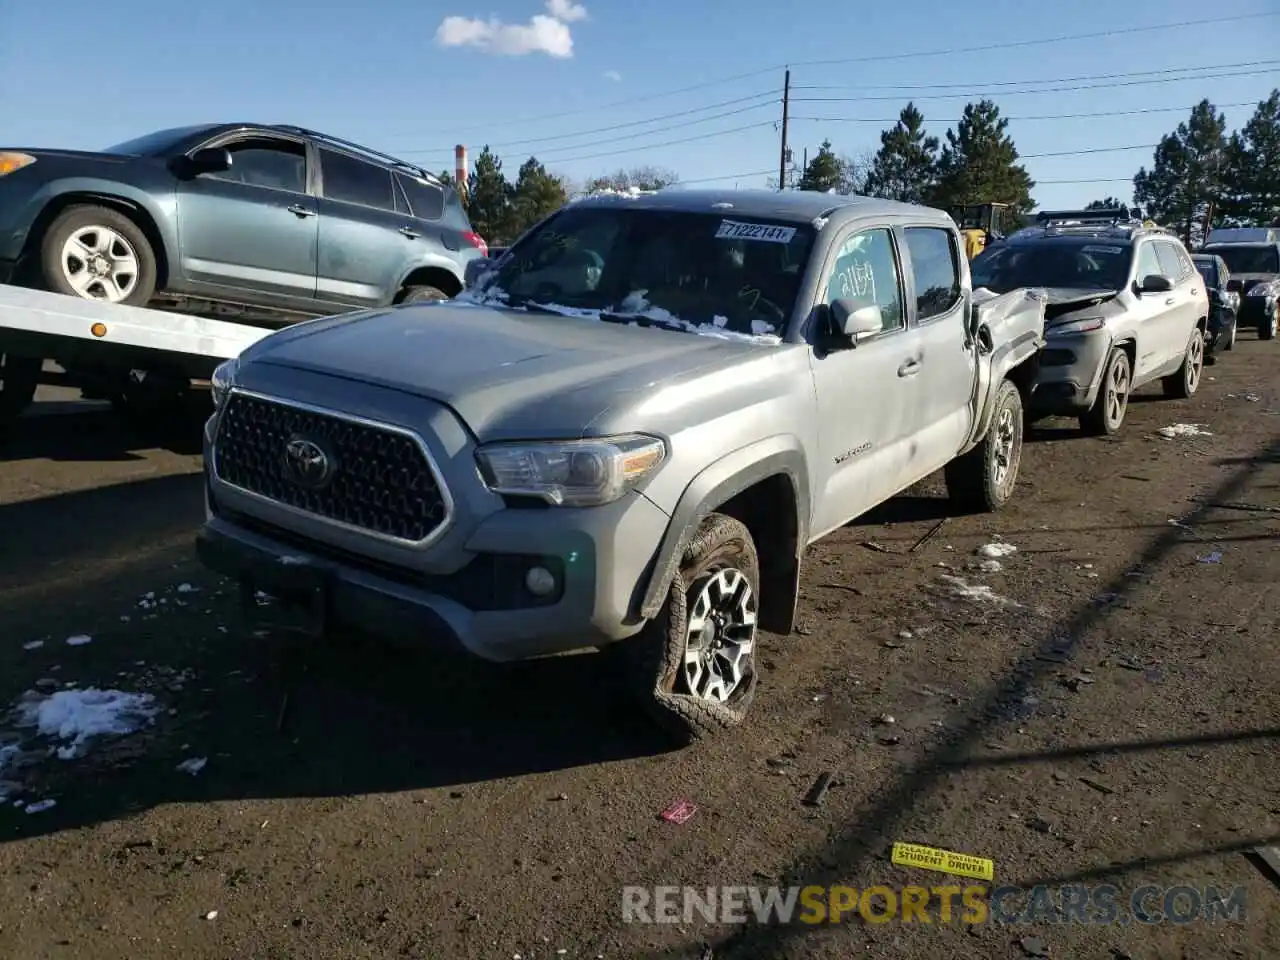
198, 191, 1044, 740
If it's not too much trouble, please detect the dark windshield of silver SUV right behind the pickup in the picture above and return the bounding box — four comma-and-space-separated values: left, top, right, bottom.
972, 241, 1133, 293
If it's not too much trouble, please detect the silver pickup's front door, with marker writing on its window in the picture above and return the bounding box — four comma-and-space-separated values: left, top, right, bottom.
810, 228, 922, 535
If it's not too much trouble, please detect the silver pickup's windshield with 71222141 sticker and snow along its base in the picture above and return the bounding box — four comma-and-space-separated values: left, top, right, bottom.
463, 205, 814, 342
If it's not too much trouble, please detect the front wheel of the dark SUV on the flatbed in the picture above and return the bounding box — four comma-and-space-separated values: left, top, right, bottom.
40, 206, 156, 306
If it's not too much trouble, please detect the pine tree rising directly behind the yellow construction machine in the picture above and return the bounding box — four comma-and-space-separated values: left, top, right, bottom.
929, 100, 1036, 218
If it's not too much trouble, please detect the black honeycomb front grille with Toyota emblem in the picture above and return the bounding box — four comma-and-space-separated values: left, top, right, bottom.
214, 392, 449, 543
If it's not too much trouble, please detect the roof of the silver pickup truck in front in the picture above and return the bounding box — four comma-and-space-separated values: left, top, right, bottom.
565, 188, 954, 225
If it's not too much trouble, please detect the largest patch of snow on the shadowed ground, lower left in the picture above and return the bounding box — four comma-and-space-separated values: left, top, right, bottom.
17, 687, 157, 760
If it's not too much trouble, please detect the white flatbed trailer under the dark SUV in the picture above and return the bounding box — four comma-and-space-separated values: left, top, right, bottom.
0, 284, 271, 416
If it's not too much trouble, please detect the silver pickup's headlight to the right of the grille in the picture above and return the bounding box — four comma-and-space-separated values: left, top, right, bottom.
476, 434, 667, 507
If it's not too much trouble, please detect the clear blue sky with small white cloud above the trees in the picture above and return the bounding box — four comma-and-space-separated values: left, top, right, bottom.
0, 0, 1280, 207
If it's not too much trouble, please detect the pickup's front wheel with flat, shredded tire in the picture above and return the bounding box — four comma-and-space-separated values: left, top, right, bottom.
622, 513, 760, 744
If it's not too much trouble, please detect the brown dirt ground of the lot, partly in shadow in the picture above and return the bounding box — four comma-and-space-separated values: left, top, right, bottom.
0, 334, 1280, 960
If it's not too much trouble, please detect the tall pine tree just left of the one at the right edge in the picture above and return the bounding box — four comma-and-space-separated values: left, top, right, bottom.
1133, 100, 1228, 243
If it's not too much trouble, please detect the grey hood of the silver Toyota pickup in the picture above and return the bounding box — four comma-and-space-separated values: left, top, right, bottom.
241, 302, 774, 442
